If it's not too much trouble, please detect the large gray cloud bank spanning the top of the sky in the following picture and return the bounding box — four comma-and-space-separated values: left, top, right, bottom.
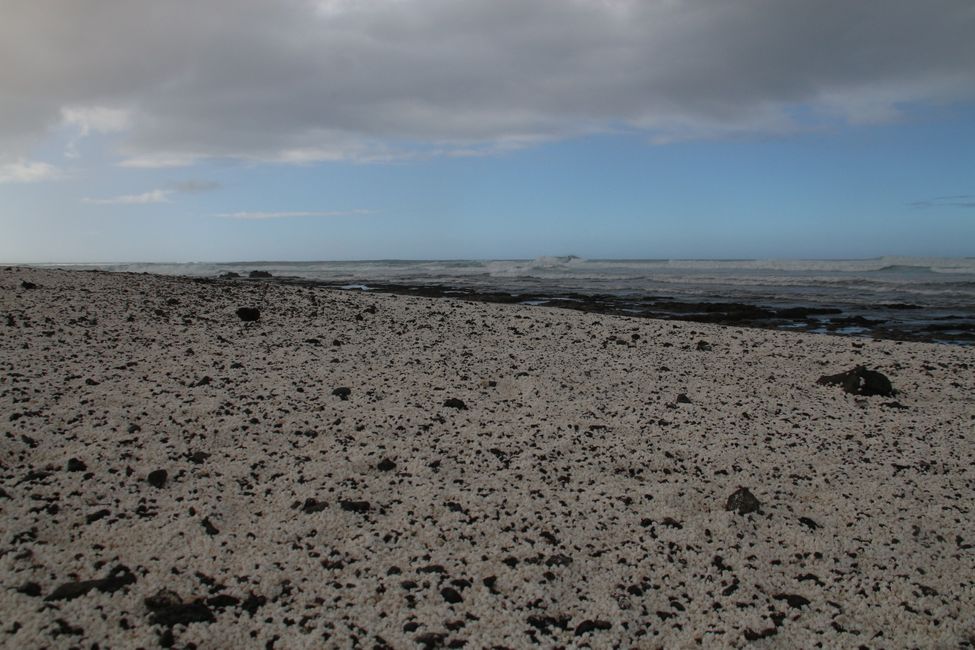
0, 0, 975, 166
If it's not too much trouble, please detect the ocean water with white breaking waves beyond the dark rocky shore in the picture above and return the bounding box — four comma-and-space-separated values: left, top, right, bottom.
49, 256, 975, 344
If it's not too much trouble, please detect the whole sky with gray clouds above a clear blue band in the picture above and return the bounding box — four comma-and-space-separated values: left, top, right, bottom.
0, 0, 975, 263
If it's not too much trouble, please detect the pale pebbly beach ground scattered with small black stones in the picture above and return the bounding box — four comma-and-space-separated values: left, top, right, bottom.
0, 269, 975, 648
